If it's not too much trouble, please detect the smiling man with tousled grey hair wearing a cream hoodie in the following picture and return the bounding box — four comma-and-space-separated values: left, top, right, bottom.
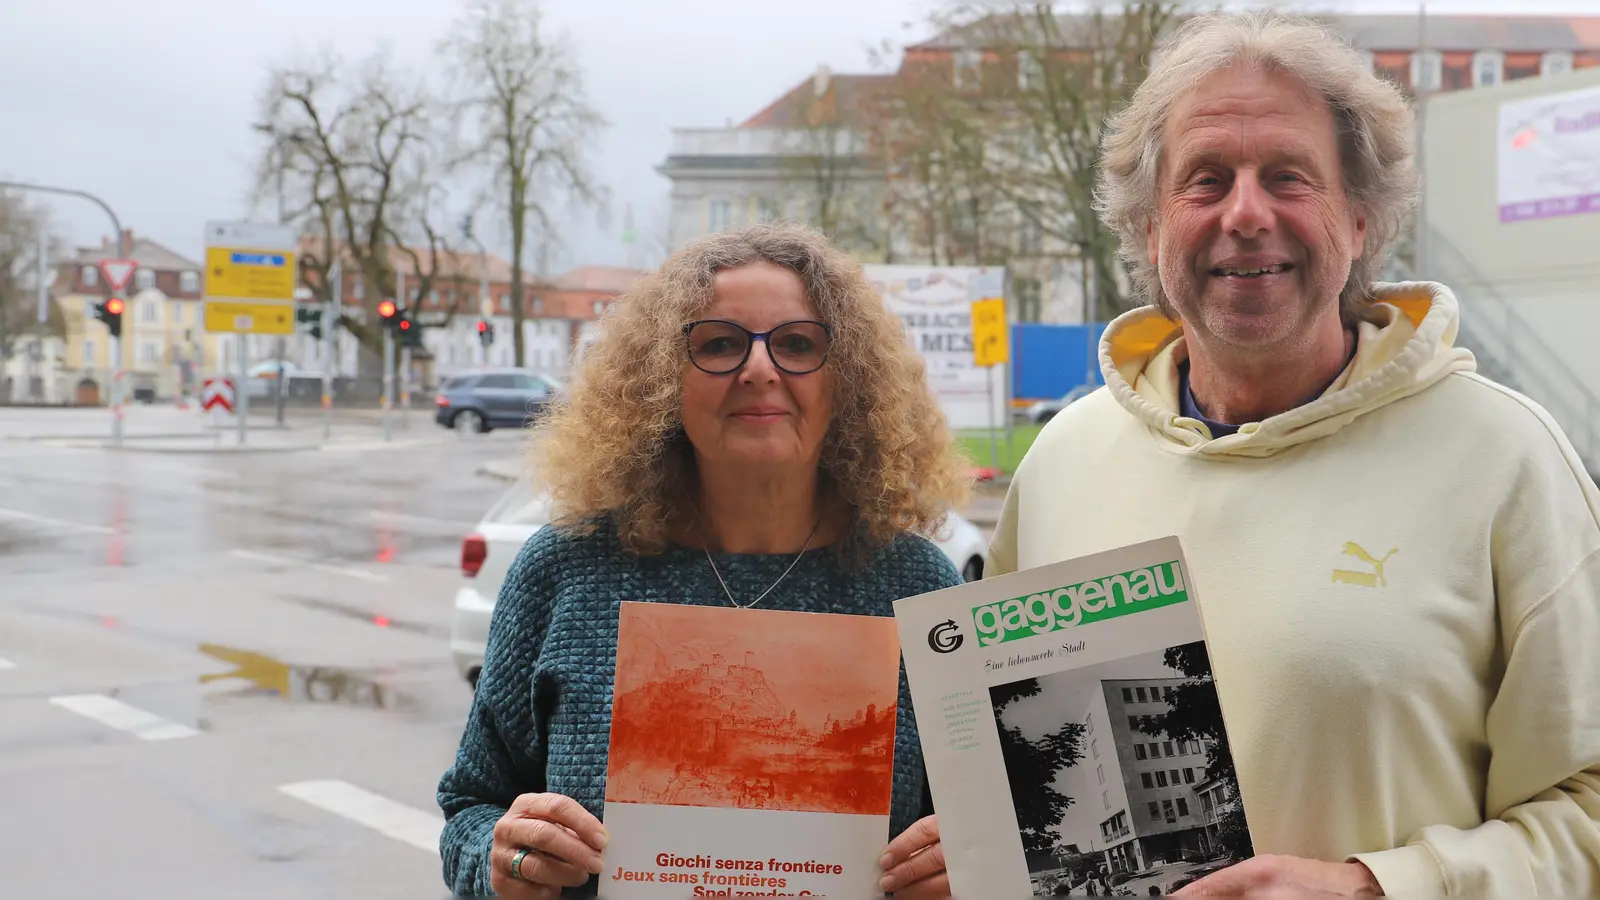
989, 8, 1600, 897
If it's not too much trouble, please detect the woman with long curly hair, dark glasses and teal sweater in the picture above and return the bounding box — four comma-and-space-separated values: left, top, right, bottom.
438, 219, 968, 897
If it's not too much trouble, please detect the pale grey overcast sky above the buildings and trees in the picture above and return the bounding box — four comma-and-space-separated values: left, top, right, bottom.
0, 0, 1594, 271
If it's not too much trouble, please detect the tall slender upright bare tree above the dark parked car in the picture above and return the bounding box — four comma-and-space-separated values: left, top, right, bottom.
440, 0, 605, 365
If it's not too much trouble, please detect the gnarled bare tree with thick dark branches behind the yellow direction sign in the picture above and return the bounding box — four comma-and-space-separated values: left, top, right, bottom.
256, 54, 440, 371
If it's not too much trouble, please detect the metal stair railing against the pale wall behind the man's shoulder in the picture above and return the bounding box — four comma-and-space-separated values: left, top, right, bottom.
1429, 229, 1600, 474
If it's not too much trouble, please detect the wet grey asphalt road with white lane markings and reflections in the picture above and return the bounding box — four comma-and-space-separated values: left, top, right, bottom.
0, 410, 517, 900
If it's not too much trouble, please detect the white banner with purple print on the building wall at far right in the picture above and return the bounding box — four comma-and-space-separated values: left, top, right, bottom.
1498, 88, 1600, 223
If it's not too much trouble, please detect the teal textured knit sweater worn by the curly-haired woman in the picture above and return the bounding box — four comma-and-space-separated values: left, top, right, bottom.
438, 515, 962, 897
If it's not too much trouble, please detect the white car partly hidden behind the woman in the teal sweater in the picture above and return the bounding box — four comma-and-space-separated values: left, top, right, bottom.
450, 482, 987, 687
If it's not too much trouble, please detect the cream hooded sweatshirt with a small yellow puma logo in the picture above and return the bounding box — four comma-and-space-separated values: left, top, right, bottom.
989, 282, 1600, 897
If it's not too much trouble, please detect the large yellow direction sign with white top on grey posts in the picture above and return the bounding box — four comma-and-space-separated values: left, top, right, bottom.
205, 221, 299, 444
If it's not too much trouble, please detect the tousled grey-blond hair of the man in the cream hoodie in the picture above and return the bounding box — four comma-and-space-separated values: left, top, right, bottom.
1094, 11, 1418, 322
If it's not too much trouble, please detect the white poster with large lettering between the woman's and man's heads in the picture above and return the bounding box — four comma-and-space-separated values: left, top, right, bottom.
866, 264, 1010, 429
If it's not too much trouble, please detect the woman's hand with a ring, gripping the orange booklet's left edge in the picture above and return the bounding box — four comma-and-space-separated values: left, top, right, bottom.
490, 794, 606, 900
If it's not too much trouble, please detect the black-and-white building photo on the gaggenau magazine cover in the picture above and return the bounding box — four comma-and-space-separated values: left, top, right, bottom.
989, 642, 1253, 897
